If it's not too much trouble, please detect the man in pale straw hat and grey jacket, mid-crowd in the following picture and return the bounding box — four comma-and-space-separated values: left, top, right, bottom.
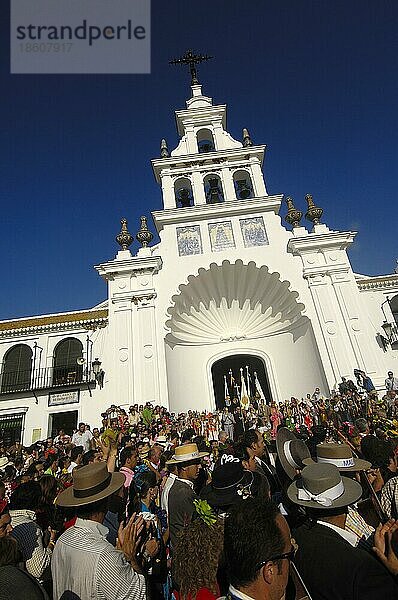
166, 444, 209, 546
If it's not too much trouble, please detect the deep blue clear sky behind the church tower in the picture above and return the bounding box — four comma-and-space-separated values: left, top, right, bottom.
0, 0, 398, 319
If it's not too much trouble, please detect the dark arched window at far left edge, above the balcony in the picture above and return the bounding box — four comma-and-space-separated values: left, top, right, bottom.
1, 344, 33, 393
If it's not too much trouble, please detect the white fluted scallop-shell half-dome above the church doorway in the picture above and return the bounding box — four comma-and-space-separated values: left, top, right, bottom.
166, 260, 308, 345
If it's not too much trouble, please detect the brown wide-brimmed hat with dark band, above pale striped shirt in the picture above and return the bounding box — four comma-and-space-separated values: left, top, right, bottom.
55, 462, 125, 507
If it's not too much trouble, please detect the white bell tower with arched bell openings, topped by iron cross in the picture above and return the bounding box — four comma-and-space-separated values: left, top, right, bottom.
152, 51, 268, 223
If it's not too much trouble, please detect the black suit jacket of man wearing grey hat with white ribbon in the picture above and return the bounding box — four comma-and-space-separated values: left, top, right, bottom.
293, 523, 398, 600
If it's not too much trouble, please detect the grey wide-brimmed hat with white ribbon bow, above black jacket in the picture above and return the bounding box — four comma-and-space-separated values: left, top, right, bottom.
287, 463, 362, 510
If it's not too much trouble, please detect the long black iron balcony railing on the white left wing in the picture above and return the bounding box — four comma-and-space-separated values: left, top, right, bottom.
0, 365, 96, 394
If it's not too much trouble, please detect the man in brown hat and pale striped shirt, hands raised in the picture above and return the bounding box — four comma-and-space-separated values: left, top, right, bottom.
51, 462, 146, 600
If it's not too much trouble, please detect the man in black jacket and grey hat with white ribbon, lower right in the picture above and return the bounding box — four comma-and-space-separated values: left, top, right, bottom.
287, 463, 398, 600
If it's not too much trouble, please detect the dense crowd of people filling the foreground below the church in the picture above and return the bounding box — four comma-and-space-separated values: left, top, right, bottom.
0, 371, 398, 600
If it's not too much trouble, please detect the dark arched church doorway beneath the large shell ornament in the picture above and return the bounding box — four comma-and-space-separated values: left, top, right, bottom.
211, 354, 272, 410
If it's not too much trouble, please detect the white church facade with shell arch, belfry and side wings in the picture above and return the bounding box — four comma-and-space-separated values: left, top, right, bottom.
0, 78, 398, 444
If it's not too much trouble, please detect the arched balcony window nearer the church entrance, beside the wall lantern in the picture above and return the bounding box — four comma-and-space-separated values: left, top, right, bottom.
53, 338, 83, 385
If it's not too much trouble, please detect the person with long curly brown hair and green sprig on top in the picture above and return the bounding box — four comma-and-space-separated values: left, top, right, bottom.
172, 500, 224, 600
